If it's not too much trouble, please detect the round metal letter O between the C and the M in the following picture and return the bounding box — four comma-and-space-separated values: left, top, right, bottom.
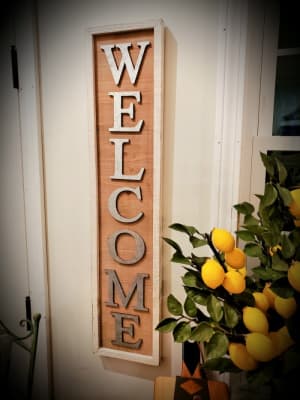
107, 229, 146, 265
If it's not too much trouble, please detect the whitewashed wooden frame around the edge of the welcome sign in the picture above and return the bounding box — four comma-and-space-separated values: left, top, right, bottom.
87, 20, 164, 365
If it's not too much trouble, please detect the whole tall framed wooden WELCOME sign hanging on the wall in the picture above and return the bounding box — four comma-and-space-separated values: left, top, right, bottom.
92, 22, 163, 364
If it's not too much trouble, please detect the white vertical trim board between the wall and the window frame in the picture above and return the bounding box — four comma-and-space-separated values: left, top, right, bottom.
211, 0, 248, 231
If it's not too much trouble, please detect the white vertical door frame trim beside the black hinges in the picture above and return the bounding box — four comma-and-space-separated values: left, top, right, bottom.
15, 1, 50, 400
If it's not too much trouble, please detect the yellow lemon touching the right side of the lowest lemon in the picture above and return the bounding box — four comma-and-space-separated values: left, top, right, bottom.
246, 332, 276, 362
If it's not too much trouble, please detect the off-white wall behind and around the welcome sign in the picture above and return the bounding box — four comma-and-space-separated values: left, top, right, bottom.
37, 0, 234, 400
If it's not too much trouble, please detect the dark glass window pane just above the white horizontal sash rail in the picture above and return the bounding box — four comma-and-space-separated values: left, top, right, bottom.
273, 55, 300, 136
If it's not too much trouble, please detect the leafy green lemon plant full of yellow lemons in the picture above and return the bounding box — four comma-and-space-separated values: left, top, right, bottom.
156, 153, 300, 398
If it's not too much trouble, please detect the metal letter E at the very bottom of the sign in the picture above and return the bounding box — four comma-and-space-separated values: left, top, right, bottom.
111, 313, 143, 349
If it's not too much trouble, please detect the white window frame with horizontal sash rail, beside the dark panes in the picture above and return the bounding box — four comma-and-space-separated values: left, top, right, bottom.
239, 1, 300, 205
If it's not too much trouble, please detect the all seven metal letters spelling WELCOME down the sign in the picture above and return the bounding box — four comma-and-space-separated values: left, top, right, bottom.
100, 41, 150, 349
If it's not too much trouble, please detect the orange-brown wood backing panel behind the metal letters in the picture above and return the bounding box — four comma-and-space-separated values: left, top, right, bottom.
94, 29, 154, 356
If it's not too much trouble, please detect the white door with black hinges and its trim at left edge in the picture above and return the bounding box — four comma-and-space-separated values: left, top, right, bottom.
0, 1, 49, 399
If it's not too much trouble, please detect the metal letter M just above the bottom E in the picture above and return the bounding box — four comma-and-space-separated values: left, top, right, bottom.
105, 269, 150, 311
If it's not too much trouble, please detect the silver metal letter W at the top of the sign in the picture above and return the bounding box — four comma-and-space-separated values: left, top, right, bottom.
101, 41, 150, 85
